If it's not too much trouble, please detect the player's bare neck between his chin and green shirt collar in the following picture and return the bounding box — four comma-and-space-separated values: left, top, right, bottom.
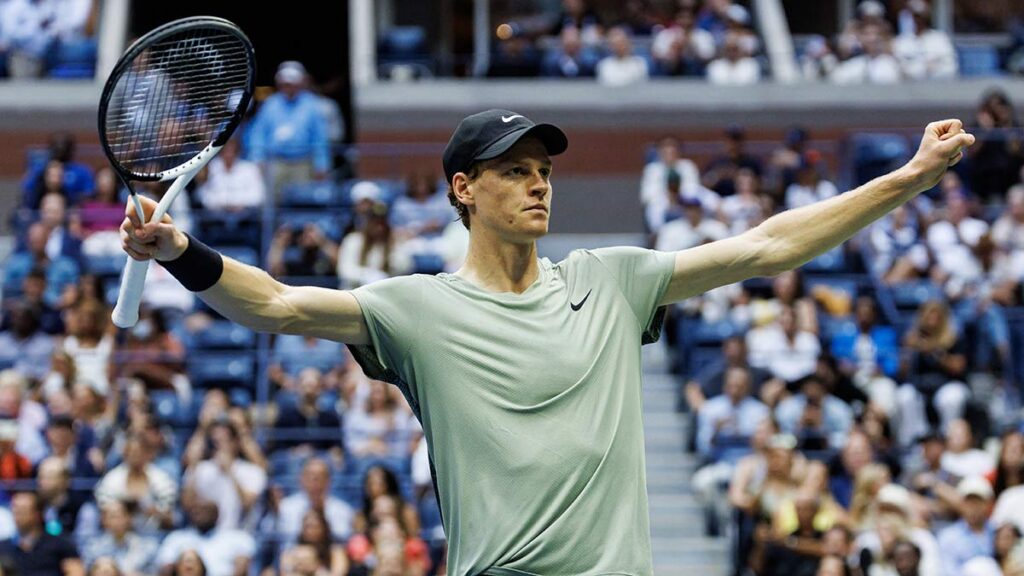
455, 228, 541, 294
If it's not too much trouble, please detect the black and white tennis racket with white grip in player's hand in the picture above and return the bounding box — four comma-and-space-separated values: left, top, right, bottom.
99, 16, 256, 328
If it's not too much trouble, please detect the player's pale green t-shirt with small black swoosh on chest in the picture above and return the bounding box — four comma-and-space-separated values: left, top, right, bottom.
352, 247, 675, 576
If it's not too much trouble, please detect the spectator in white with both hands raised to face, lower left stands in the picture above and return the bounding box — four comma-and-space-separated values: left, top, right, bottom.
184, 418, 266, 530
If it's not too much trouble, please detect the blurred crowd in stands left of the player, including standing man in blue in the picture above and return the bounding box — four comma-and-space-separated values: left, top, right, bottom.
0, 61, 456, 576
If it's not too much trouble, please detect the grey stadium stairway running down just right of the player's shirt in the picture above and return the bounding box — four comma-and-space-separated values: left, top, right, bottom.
643, 342, 728, 576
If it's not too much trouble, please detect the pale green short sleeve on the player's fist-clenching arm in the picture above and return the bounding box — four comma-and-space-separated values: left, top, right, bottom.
590, 246, 676, 343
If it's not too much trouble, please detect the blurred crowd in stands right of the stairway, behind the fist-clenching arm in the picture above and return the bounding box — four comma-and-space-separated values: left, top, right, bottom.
640, 91, 1024, 576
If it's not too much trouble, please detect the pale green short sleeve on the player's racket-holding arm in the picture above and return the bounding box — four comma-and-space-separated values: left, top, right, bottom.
348, 276, 423, 384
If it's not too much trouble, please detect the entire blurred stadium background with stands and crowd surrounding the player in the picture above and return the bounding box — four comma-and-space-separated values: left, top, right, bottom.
0, 0, 1024, 576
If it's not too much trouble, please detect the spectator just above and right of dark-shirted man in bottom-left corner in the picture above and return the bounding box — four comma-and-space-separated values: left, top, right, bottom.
36, 456, 98, 541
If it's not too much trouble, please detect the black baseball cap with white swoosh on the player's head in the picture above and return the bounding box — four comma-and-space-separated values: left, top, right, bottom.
443, 109, 569, 183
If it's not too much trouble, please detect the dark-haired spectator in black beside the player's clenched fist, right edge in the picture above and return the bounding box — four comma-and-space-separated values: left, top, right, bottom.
967, 89, 1024, 202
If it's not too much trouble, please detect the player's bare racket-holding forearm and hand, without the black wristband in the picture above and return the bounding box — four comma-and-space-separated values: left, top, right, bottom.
121, 198, 370, 344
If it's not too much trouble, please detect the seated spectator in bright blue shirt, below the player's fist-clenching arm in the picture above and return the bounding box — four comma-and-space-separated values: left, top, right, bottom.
830, 296, 899, 417
